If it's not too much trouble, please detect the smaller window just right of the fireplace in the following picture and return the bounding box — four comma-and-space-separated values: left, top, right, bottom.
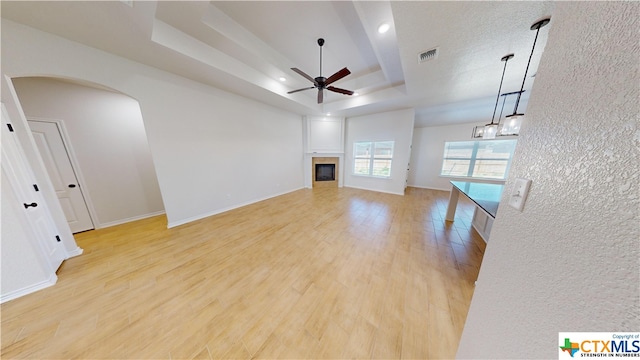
353, 141, 393, 178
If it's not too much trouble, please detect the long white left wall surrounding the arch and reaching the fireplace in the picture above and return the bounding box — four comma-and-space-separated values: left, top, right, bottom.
2, 19, 303, 226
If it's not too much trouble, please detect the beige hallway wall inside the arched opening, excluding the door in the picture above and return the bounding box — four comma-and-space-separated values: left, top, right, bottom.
13, 78, 164, 228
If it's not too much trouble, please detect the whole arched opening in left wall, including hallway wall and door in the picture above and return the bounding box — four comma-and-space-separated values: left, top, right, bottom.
12, 77, 164, 232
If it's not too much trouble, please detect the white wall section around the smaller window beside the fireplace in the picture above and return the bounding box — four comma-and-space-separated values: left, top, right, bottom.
344, 109, 415, 195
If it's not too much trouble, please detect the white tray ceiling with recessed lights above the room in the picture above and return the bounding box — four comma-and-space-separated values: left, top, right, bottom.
2, 0, 554, 127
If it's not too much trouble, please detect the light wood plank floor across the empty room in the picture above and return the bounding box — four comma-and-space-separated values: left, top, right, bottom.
0, 188, 485, 359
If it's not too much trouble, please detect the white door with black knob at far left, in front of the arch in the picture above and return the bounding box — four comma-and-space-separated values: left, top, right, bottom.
2, 104, 66, 272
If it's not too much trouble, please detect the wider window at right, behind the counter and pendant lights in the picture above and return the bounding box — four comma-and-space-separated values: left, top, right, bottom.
440, 140, 516, 179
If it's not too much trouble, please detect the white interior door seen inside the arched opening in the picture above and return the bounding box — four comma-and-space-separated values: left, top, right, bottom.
29, 120, 94, 233
